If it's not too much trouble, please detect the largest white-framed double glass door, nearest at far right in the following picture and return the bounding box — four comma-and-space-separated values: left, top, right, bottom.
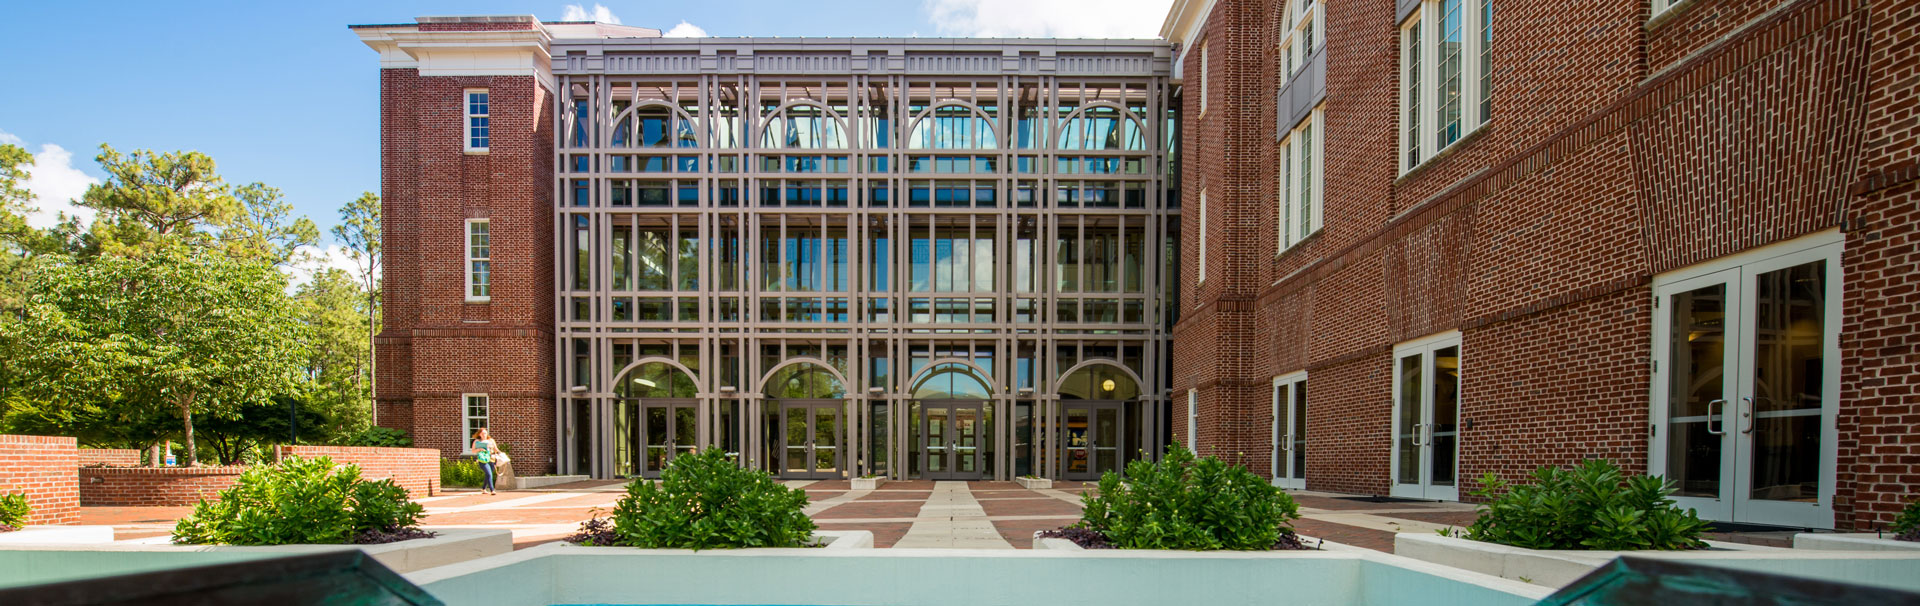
1649, 234, 1839, 527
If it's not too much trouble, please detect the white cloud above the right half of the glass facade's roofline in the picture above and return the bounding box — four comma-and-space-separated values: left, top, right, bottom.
922, 0, 1173, 38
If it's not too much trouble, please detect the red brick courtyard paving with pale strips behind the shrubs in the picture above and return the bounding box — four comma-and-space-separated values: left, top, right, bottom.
81, 479, 1473, 552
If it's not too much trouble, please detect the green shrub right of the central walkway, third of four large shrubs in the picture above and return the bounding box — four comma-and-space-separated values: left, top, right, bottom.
1079, 443, 1300, 550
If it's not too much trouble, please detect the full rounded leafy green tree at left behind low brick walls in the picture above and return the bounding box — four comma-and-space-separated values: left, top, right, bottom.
8, 247, 307, 464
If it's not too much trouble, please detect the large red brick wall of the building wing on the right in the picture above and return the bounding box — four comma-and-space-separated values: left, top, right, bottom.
1173, 0, 1920, 529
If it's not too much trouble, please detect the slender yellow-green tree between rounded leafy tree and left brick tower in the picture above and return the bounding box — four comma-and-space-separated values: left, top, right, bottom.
294, 268, 371, 435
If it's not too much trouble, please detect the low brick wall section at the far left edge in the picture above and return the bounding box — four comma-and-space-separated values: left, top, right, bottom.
0, 435, 81, 525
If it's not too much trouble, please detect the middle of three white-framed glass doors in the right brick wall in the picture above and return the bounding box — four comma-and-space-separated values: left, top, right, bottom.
1392, 334, 1459, 501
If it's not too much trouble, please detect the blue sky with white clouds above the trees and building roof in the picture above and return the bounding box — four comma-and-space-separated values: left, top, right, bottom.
0, 0, 1171, 270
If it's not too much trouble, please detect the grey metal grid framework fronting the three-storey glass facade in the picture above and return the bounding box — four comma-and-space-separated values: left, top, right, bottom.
551, 38, 1179, 479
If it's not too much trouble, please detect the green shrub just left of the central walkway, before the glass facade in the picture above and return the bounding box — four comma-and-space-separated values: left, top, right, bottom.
612, 449, 814, 548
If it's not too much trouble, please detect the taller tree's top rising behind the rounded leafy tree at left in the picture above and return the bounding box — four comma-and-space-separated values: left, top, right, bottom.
79, 146, 246, 255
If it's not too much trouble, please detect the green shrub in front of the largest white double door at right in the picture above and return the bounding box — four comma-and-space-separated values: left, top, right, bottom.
1467, 458, 1707, 550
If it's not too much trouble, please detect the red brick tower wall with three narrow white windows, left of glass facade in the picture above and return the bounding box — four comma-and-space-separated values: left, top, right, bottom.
374, 55, 555, 478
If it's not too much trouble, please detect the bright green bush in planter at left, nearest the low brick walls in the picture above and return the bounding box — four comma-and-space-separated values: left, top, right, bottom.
173, 456, 430, 545
